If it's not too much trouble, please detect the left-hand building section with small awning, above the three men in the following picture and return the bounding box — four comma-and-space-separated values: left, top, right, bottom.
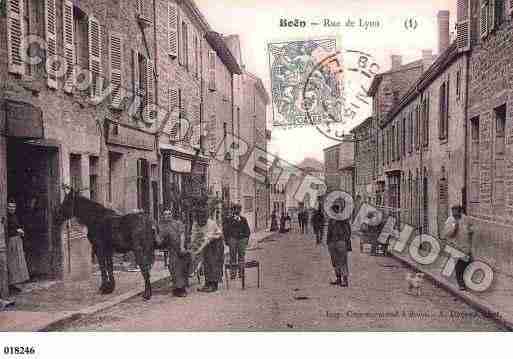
155, 0, 240, 224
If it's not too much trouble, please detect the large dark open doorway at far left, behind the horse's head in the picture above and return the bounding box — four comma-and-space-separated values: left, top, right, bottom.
7, 140, 62, 280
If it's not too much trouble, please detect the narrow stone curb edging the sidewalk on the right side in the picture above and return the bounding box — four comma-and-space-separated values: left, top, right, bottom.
390, 253, 513, 331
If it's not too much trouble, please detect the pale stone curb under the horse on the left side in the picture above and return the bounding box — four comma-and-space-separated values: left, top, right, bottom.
39, 275, 169, 332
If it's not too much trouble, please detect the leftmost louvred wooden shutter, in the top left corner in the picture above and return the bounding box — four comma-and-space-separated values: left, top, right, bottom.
7, 0, 25, 75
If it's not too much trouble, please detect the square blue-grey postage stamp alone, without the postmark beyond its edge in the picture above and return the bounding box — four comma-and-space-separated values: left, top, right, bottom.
268, 38, 344, 127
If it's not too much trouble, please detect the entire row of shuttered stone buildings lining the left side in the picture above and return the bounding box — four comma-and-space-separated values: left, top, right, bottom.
0, 0, 265, 292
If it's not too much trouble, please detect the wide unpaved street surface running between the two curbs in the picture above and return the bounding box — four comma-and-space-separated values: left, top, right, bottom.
59, 233, 503, 331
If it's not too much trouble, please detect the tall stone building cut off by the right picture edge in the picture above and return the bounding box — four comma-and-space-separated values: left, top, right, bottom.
464, 0, 513, 274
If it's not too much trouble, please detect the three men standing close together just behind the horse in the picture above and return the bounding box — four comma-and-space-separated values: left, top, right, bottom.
159, 203, 251, 297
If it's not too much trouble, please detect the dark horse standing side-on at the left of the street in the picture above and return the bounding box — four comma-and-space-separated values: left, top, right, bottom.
55, 189, 156, 300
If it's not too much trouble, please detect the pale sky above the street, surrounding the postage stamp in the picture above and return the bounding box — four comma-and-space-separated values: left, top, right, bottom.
195, 0, 456, 163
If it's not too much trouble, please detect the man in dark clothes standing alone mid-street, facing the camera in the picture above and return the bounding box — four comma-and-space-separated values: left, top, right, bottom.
327, 204, 351, 287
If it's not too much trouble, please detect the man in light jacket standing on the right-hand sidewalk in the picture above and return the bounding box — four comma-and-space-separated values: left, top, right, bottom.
442, 205, 473, 290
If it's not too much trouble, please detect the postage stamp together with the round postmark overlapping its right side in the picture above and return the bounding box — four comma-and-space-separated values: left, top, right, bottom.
268, 38, 380, 140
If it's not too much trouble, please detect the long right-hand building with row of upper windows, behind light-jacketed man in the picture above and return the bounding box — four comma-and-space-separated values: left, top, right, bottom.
380, 43, 467, 236
